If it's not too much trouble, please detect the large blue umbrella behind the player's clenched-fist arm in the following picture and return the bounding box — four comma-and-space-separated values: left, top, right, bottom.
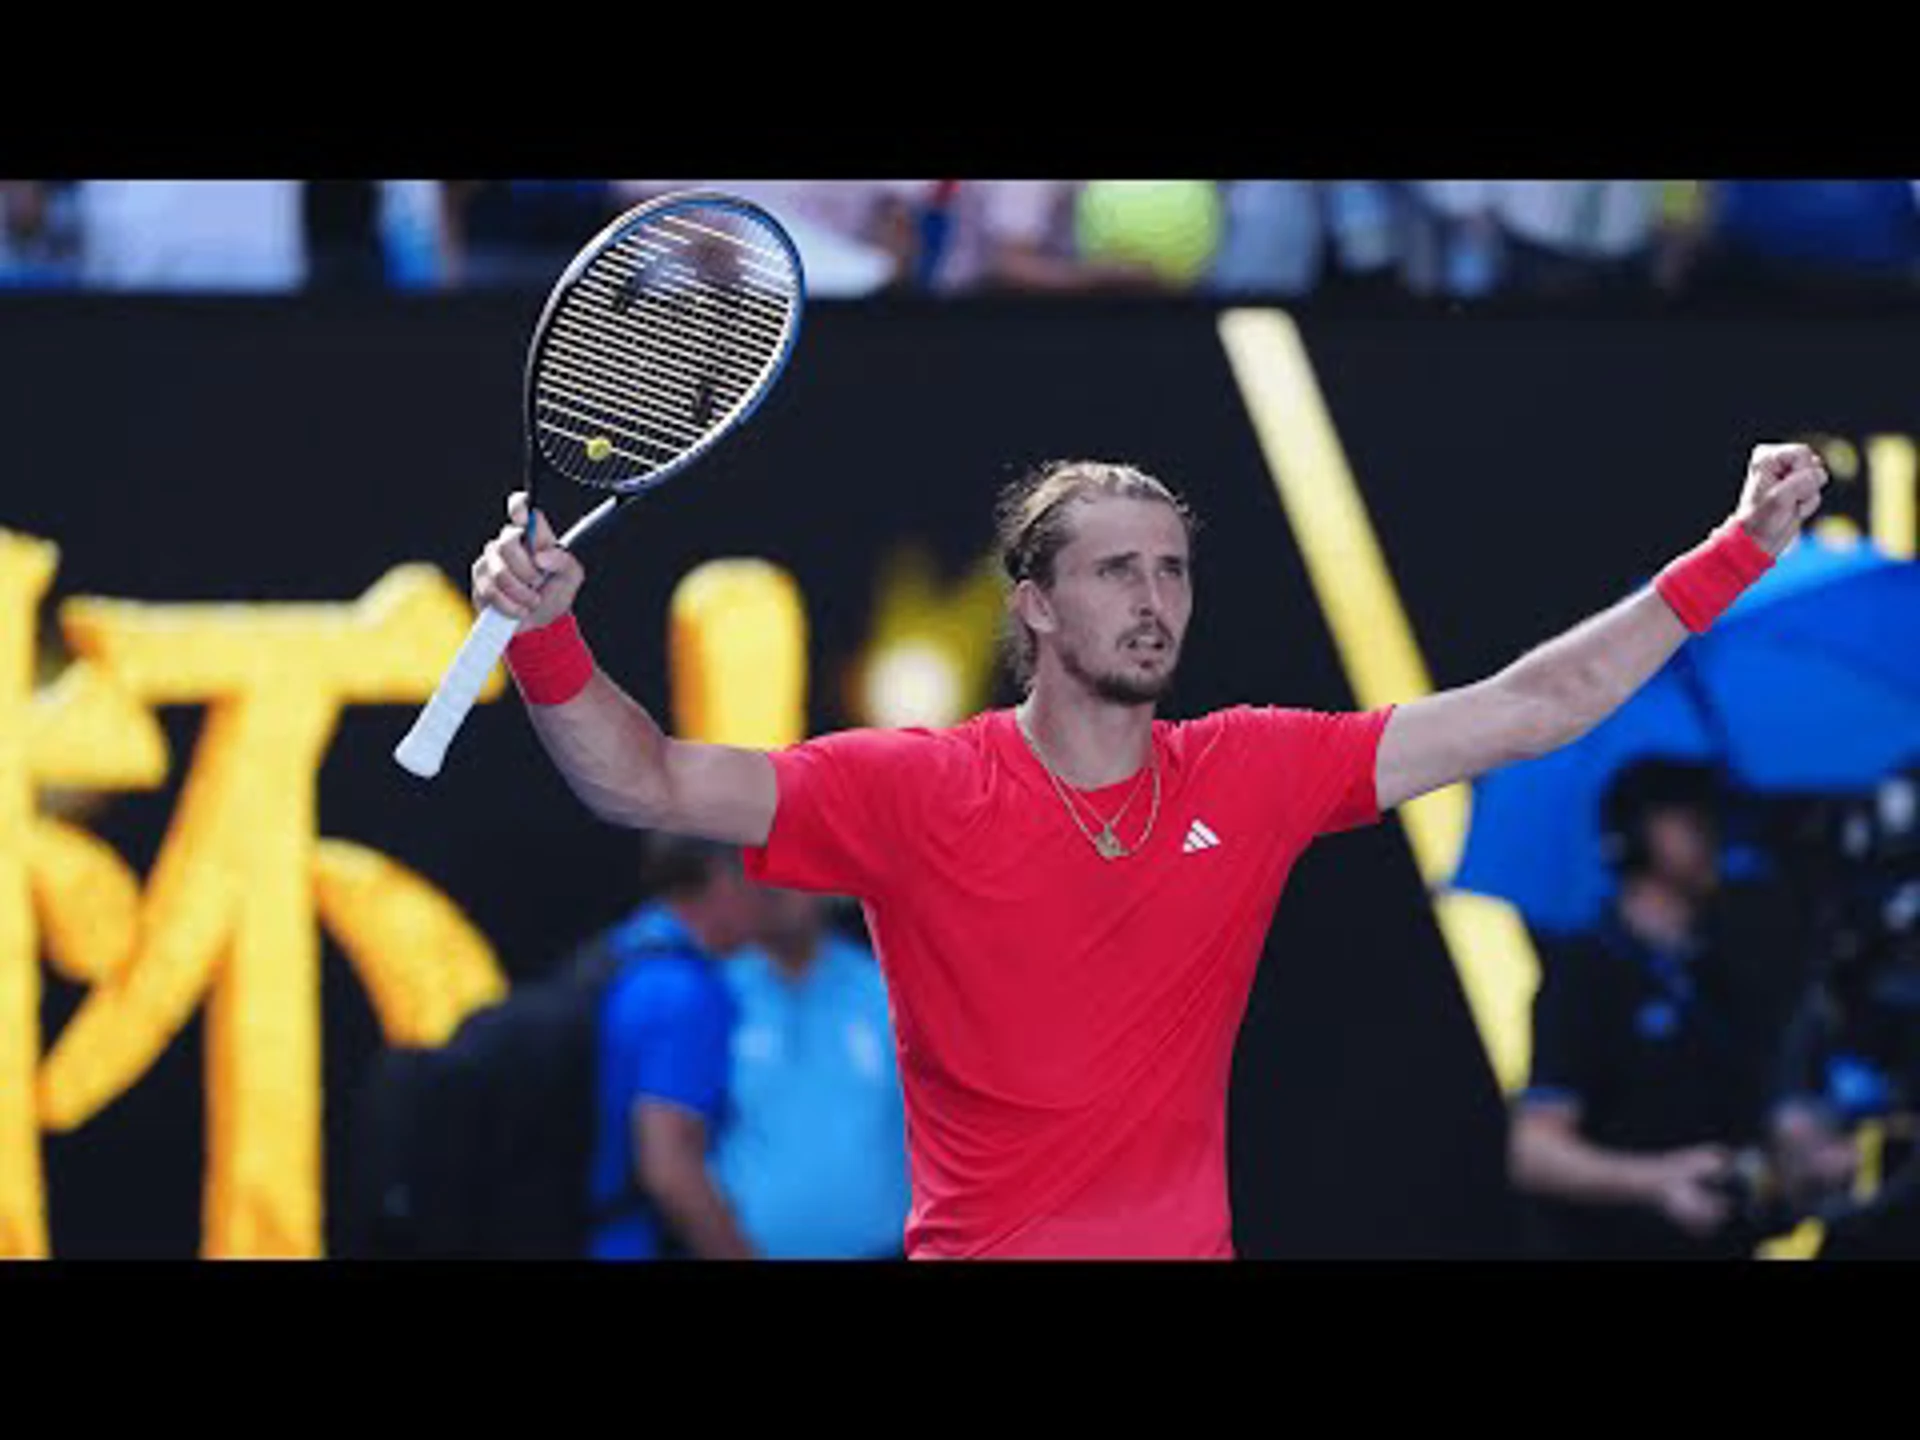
1452, 538, 1920, 931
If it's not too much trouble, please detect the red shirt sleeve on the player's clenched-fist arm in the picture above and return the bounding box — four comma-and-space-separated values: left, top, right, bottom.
1233, 705, 1394, 837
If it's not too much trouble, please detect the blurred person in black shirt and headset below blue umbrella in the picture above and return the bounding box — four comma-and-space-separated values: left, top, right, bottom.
1509, 758, 1801, 1260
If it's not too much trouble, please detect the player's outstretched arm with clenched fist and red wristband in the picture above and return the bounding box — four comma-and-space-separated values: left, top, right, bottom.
1375, 445, 1826, 810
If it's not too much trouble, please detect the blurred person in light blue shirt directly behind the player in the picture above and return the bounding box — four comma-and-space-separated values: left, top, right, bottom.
716, 889, 910, 1260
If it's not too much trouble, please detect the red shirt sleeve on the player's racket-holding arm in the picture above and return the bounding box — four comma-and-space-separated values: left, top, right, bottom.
741, 730, 939, 899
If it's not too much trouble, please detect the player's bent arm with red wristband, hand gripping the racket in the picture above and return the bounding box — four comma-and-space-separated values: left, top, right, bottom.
472, 492, 778, 845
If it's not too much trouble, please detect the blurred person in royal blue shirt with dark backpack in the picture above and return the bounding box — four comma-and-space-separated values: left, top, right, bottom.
588, 833, 764, 1260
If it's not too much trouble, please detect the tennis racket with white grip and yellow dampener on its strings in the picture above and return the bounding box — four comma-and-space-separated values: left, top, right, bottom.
394, 192, 806, 780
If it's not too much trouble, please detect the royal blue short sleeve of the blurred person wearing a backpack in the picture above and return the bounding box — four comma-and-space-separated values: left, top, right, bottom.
607, 962, 732, 1125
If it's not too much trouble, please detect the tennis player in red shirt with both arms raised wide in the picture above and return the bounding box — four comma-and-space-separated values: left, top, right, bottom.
472, 445, 1828, 1260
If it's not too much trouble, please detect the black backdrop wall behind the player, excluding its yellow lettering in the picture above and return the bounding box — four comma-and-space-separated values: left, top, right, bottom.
0, 296, 1920, 1256
